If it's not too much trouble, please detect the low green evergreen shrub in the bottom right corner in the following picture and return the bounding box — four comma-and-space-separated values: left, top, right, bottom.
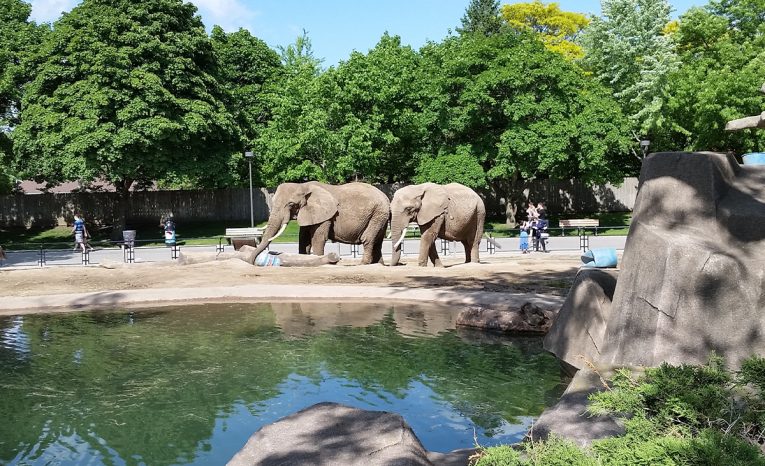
476, 356, 765, 466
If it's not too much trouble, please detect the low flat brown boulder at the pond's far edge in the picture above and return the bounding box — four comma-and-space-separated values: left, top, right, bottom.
455, 303, 555, 335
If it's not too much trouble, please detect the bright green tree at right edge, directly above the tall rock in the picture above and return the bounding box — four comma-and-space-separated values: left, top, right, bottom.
654, 0, 765, 153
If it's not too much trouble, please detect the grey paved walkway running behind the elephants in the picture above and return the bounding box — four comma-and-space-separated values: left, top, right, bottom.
0, 235, 627, 267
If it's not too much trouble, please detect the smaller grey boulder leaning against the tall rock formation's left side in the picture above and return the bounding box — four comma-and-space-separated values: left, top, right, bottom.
544, 268, 617, 369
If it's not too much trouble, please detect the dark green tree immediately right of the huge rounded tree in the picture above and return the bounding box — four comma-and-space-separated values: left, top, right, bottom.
210, 26, 282, 167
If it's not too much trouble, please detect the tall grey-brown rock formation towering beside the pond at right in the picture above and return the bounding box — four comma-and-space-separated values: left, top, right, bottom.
598, 152, 765, 367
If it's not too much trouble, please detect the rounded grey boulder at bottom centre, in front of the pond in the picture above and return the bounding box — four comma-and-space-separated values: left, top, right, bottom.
228, 403, 474, 466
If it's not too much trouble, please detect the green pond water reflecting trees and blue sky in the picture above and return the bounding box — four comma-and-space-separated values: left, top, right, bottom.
0, 303, 566, 466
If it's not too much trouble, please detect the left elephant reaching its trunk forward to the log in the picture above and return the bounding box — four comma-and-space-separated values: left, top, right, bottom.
255, 181, 390, 264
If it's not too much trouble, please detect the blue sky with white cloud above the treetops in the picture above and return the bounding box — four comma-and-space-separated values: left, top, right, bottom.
27, 0, 707, 67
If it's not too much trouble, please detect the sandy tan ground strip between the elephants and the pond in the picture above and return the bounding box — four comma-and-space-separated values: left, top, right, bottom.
0, 254, 580, 296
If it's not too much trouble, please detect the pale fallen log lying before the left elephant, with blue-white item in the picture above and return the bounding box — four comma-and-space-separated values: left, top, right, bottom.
178, 245, 340, 267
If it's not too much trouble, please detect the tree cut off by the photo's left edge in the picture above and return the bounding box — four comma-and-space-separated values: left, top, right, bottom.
0, 0, 48, 193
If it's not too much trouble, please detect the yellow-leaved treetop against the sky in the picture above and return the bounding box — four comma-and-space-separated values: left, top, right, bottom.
502, 0, 590, 60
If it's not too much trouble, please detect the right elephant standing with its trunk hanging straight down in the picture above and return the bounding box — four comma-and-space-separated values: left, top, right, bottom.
391, 183, 486, 267
